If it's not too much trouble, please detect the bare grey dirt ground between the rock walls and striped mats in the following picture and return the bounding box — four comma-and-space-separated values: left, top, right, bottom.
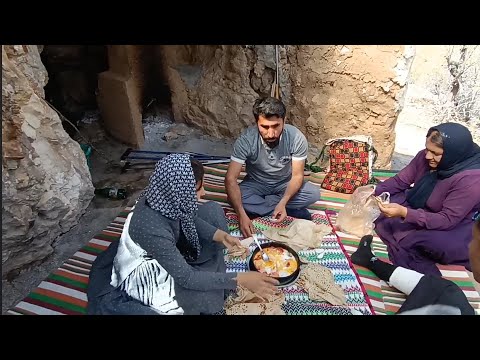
2, 116, 476, 314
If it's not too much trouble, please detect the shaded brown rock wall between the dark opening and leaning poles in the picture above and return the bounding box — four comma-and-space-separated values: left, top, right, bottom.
160, 45, 260, 137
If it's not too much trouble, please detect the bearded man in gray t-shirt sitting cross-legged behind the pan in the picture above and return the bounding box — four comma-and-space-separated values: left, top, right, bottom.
225, 97, 320, 237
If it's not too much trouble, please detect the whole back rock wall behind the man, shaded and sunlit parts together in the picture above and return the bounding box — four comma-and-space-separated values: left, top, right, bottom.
159, 45, 413, 168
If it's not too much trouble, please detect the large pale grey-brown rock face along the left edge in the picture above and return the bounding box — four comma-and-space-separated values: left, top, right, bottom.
2, 45, 93, 277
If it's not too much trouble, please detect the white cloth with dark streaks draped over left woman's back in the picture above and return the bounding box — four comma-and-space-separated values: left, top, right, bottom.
110, 209, 184, 315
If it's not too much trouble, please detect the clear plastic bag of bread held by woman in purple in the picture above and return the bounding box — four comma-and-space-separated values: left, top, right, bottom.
336, 185, 390, 237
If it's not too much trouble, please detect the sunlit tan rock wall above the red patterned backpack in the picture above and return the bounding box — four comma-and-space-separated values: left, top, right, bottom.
288, 45, 413, 168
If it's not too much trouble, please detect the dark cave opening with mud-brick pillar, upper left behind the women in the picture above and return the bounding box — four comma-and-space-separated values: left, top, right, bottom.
41, 45, 173, 148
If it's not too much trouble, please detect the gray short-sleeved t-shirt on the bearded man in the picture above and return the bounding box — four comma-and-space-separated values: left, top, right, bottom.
231, 124, 308, 185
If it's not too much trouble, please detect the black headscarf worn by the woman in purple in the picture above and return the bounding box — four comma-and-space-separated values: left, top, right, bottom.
407, 123, 480, 209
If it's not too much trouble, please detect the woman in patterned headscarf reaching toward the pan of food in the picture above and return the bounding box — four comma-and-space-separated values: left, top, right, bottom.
87, 154, 277, 314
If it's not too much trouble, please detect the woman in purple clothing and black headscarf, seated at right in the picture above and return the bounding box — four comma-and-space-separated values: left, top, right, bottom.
375, 123, 480, 275
